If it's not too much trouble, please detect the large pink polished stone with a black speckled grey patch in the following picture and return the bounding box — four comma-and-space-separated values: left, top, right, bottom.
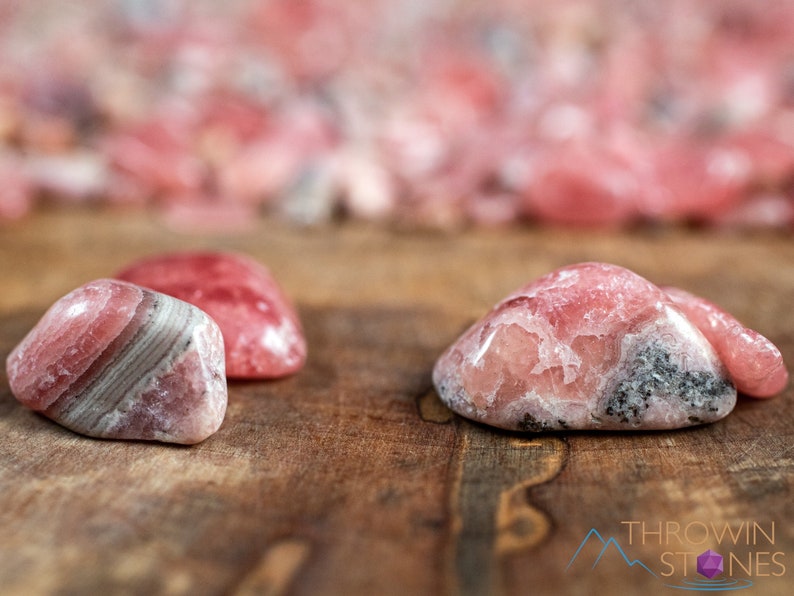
433, 263, 736, 431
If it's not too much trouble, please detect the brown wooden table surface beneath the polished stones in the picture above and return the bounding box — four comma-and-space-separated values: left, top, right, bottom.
0, 210, 794, 596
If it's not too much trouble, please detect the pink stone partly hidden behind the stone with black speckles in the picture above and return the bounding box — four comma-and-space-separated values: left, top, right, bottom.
662, 287, 788, 397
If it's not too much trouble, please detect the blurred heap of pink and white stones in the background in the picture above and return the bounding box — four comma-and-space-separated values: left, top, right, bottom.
0, 0, 794, 230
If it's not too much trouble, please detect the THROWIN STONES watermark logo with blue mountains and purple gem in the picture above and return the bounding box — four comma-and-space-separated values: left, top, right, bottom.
566, 520, 786, 592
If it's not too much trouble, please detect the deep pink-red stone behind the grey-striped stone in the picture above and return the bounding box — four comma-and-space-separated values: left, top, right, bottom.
116, 252, 306, 379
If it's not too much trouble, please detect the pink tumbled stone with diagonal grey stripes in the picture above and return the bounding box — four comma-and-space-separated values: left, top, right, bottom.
6, 279, 227, 444
